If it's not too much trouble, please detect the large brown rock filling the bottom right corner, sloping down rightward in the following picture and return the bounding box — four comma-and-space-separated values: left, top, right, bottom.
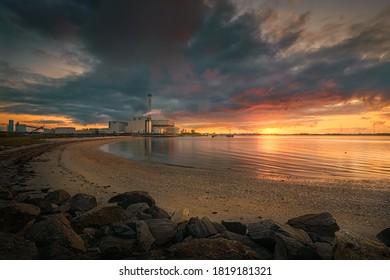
333, 230, 390, 260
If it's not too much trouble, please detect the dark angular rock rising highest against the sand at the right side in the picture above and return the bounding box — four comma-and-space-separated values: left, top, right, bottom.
287, 212, 340, 242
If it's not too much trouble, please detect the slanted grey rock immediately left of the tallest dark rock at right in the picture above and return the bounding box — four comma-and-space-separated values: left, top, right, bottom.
248, 219, 312, 252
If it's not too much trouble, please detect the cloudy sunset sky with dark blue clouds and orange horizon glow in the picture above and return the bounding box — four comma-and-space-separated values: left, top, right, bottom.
0, 0, 390, 133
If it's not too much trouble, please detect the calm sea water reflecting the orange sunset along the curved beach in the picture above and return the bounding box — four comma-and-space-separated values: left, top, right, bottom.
101, 135, 390, 179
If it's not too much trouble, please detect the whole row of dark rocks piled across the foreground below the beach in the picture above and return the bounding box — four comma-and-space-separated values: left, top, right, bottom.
0, 187, 390, 260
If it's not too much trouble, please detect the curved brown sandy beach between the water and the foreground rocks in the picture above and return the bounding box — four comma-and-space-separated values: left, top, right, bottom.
25, 137, 390, 238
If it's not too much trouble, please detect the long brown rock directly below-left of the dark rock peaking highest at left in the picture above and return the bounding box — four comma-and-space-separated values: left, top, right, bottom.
72, 205, 125, 232
